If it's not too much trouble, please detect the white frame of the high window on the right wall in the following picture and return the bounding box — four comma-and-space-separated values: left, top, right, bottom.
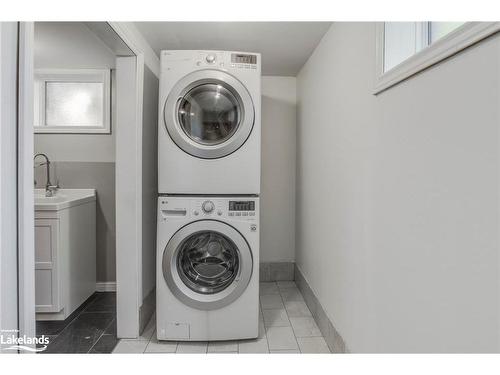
373, 22, 500, 95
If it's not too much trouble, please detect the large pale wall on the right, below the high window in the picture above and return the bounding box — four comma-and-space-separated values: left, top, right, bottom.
297, 23, 500, 352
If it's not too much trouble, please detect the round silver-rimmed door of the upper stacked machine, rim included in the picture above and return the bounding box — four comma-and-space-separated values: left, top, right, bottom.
164, 70, 255, 159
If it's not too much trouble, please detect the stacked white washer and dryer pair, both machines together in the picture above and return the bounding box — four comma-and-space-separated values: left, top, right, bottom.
156, 51, 261, 341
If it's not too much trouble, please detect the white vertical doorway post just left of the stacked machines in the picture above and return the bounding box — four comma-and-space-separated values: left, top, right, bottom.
115, 54, 144, 338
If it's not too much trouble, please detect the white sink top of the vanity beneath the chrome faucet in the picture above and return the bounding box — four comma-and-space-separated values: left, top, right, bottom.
35, 189, 96, 211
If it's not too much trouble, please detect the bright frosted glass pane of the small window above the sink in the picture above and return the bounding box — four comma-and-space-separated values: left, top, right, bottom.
45, 82, 104, 127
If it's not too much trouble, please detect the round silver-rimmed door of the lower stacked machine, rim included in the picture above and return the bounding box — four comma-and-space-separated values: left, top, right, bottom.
162, 220, 253, 310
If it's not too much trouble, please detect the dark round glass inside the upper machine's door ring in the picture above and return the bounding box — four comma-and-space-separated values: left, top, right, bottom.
178, 83, 242, 145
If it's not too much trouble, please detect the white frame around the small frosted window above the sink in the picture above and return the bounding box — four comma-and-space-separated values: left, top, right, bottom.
33, 69, 111, 134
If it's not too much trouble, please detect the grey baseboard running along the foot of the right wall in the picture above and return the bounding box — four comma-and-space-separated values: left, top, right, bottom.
294, 265, 349, 353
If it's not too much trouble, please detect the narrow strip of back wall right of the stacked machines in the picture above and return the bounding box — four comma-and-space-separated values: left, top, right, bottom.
260, 76, 296, 262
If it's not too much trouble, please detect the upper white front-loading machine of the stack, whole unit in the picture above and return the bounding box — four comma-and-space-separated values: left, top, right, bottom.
158, 51, 261, 194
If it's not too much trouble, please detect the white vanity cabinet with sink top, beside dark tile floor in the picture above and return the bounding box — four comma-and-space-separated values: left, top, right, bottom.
35, 189, 96, 320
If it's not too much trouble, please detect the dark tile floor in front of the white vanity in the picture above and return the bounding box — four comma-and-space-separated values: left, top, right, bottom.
36, 292, 118, 353
